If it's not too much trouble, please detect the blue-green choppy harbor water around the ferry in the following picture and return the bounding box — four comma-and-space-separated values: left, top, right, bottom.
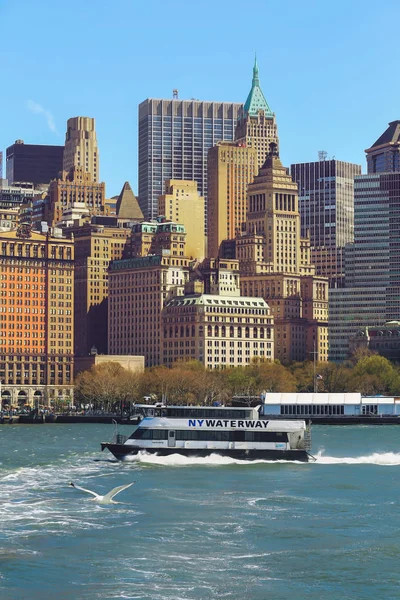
0, 424, 400, 600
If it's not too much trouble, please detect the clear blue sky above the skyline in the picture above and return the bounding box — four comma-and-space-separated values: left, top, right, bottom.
0, 0, 400, 196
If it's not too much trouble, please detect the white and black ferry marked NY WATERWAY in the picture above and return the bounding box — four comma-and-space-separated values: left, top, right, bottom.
101, 404, 313, 462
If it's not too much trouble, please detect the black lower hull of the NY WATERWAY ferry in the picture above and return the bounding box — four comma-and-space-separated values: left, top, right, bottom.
101, 442, 312, 462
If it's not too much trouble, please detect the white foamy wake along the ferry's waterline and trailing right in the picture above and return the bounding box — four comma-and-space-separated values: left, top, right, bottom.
124, 450, 400, 467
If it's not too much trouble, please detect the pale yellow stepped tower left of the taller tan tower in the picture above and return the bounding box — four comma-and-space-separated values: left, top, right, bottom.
158, 179, 206, 260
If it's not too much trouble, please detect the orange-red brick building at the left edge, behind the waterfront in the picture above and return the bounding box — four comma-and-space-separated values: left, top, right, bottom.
0, 225, 74, 406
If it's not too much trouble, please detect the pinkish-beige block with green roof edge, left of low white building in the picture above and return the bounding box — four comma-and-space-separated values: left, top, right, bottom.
108, 253, 189, 367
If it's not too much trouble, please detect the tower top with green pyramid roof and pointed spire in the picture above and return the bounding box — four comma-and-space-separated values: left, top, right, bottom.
235, 60, 279, 168
